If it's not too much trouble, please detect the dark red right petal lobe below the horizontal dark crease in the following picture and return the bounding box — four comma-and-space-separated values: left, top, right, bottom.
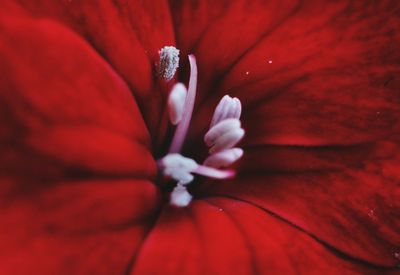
205, 141, 400, 266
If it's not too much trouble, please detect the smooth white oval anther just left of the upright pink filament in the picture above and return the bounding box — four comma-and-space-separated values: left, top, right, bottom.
168, 83, 187, 125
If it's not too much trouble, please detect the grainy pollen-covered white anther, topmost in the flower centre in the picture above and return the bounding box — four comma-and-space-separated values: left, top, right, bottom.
158, 46, 179, 81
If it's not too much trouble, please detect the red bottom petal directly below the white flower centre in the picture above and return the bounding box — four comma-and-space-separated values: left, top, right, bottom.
131, 198, 388, 274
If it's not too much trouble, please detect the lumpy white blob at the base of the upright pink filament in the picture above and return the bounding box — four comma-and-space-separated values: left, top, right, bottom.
161, 154, 199, 185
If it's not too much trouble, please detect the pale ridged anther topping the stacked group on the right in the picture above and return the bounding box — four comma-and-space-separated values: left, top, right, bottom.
210, 95, 242, 128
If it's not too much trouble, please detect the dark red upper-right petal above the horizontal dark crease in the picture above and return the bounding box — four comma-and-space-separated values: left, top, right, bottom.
185, 1, 400, 148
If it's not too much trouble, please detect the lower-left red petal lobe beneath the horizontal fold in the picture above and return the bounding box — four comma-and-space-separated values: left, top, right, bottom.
0, 179, 158, 274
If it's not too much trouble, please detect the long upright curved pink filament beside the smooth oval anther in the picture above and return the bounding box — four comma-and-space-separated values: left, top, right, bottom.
169, 55, 197, 154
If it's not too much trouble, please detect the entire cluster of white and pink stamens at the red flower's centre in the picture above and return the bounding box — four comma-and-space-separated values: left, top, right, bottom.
158, 46, 244, 207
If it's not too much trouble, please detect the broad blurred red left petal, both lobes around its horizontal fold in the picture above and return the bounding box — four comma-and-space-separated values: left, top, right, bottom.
0, 9, 159, 274
